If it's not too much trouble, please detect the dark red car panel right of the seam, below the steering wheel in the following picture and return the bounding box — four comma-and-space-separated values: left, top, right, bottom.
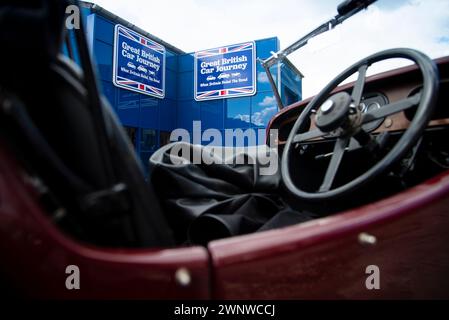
209, 172, 449, 299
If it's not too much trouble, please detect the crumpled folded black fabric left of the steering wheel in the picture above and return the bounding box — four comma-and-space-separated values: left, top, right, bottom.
150, 144, 313, 245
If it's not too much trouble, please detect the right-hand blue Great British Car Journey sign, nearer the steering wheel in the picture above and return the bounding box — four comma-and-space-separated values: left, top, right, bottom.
194, 42, 256, 101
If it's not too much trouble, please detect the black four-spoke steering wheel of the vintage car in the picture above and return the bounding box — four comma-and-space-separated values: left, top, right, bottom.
281, 48, 439, 200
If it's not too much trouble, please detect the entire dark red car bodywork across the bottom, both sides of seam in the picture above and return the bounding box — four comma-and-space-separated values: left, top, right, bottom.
0, 58, 449, 299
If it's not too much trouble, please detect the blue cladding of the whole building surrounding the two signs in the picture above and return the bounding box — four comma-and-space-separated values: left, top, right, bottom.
83, 5, 302, 172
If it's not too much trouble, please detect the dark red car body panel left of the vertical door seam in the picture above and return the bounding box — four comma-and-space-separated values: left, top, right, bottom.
0, 143, 210, 299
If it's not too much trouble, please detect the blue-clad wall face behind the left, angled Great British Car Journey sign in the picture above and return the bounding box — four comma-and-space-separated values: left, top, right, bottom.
87, 13, 178, 168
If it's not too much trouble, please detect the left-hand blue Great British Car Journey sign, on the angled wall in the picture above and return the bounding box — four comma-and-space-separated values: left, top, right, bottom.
113, 25, 165, 98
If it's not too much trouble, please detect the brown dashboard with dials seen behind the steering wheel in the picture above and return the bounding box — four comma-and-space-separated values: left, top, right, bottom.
267, 57, 449, 146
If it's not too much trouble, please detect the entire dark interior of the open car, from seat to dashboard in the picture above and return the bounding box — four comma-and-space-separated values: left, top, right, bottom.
0, 1, 449, 300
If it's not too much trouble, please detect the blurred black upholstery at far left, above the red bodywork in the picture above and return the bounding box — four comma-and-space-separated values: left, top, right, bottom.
0, 0, 173, 247
